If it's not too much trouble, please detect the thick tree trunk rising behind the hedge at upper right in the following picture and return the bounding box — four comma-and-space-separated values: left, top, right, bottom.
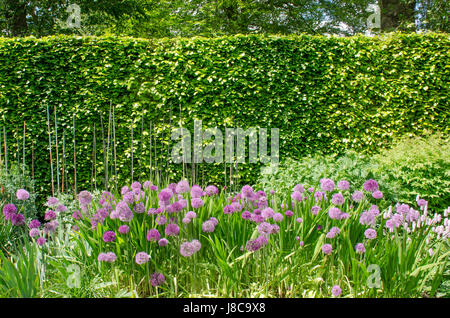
380, 0, 416, 32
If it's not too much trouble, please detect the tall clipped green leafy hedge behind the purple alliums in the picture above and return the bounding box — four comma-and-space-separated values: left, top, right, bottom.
0, 34, 450, 199
